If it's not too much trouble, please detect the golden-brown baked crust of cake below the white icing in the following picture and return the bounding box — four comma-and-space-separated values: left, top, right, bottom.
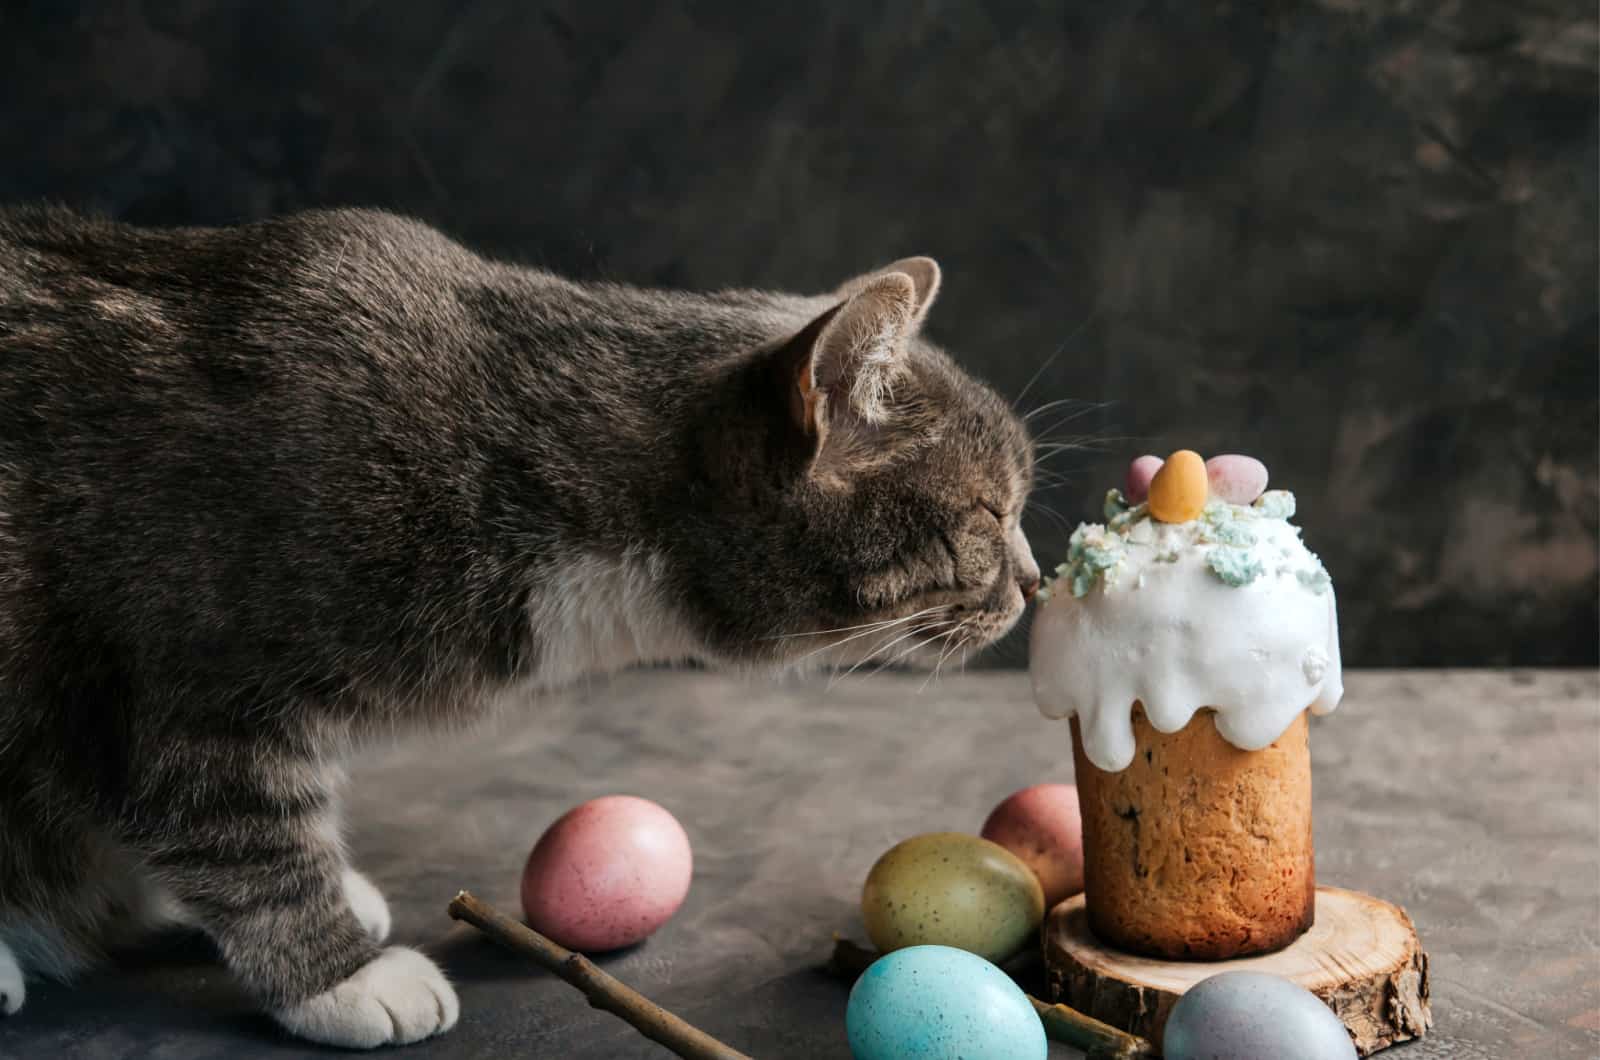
1072, 703, 1317, 961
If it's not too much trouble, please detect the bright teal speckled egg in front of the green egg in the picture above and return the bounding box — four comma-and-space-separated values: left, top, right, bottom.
845, 946, 1048, 1060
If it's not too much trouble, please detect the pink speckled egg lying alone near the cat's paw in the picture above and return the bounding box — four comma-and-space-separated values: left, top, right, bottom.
522, 796, 694, 953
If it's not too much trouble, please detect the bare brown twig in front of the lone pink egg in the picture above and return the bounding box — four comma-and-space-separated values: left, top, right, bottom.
450, 890, 750, 1060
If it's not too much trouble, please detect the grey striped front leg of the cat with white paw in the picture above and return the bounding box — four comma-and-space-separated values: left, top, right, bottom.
130, 756, 459, 1049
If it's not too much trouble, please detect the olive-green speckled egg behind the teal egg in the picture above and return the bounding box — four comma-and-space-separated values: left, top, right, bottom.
861, 831, 1045, 962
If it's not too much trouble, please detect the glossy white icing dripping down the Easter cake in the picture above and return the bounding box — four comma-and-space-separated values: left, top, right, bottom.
1030, 493, 1344, 772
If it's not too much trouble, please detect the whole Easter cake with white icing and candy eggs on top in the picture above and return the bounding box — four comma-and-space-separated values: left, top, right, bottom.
1030, 450, 1342, 961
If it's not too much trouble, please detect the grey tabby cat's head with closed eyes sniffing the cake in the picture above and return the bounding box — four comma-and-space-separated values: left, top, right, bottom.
674, 258, 1038, 665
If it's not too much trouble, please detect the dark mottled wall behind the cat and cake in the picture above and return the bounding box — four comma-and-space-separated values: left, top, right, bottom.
0, 0, 1600, 665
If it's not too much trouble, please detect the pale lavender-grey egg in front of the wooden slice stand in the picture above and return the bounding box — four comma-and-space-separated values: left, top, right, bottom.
1162, 972, 1355, 1060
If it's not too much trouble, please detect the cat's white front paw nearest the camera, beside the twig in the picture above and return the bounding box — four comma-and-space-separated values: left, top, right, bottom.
272, 946, 461, 1049
